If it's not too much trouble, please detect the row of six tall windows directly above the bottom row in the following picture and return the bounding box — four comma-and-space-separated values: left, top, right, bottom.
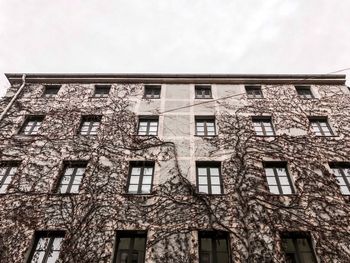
0, 161, 350, 195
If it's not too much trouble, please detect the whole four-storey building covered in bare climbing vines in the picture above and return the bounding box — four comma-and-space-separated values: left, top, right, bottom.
0, 74, 350, 263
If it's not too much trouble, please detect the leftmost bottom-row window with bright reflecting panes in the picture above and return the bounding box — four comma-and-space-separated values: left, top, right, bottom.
28, 231, 64, 263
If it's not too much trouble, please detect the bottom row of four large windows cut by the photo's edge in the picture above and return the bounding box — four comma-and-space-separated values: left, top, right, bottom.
27, 231, 316, 263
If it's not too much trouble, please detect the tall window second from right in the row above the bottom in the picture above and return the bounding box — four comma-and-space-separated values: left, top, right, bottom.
264, 162, 294, 195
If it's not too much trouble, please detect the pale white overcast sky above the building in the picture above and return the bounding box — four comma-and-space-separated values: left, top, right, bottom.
0, 0, 350, 95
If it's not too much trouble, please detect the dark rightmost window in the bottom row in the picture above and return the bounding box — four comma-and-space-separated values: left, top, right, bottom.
281, 232, 316, 263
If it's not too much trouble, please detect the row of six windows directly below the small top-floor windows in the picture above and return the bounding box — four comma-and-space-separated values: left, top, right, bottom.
20, 115, 334, 136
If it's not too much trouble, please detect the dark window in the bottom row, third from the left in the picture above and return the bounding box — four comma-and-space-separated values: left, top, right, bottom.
199, 231, 231, 263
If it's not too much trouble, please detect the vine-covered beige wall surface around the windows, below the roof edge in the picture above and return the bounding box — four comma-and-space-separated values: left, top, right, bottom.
0, 83, 350, 263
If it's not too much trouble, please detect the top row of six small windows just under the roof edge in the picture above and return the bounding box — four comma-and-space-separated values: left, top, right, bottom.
43, 85, 315, 99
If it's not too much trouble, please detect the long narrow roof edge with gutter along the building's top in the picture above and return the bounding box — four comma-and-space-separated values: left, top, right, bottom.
5, 73, 346, 85
